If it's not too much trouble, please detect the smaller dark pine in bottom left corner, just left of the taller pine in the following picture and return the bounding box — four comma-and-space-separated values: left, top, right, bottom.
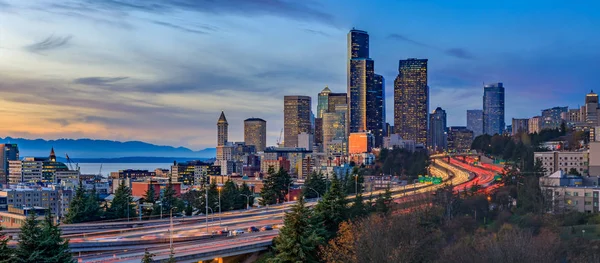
15, 211, 45, 263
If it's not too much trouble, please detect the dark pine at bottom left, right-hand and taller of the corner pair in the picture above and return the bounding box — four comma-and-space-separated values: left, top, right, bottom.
38, 210, 74, 263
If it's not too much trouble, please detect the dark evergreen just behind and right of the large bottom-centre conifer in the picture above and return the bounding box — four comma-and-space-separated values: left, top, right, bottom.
315, 177, 348, 240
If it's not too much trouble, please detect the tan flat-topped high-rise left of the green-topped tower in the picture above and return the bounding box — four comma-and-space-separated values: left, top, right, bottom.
283, 96, 312, 147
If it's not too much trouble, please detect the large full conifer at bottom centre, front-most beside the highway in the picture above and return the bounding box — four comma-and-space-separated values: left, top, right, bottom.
269, 196, 323, 263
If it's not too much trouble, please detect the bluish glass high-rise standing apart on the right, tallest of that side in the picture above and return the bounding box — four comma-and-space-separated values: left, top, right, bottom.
483, 83, 506, 135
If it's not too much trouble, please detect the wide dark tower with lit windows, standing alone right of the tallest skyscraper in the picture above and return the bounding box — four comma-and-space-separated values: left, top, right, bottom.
394, 58, 429, 146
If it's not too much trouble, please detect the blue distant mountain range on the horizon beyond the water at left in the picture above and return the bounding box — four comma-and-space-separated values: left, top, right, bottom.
0, 137, 216, 159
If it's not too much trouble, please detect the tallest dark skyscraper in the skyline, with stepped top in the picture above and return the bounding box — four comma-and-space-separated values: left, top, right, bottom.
346, 29, 375, 134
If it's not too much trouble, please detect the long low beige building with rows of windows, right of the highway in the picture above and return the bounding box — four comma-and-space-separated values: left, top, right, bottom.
533, 151, 590, 176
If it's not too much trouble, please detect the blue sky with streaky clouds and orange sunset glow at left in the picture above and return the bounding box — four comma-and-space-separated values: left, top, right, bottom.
0, 0, 600, 150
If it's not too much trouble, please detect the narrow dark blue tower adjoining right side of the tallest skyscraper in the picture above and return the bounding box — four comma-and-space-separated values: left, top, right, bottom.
367, 74, 385, 147
